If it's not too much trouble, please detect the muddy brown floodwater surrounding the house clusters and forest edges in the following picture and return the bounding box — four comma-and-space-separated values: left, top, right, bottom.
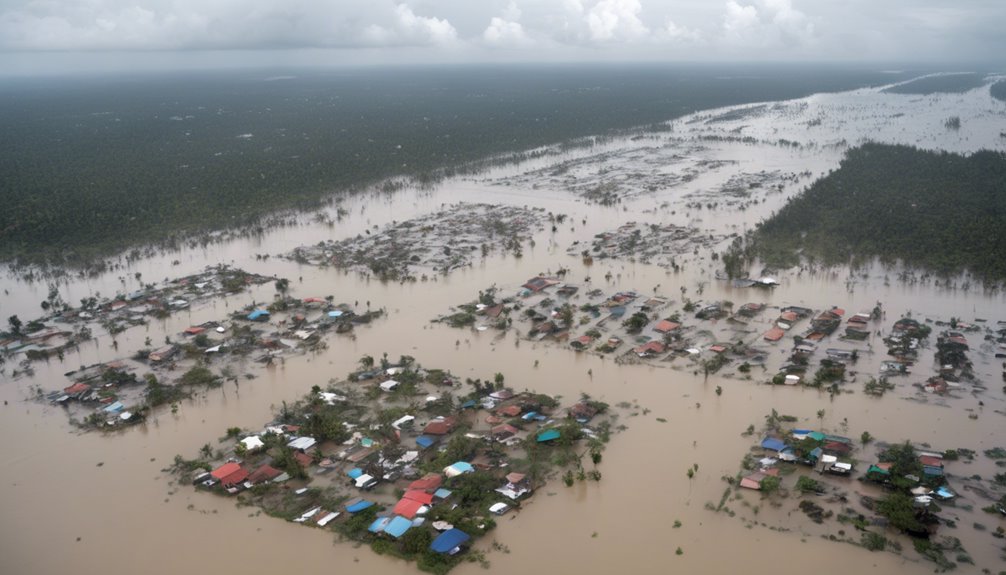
0, 79, 1006, 575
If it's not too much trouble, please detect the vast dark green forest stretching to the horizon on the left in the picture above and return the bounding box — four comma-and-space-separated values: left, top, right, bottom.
0, 65, 904, 263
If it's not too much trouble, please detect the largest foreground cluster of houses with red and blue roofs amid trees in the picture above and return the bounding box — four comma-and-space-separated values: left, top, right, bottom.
175, 355, 614, 572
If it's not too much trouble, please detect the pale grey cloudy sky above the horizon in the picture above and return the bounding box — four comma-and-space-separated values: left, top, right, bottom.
0, 0, 1006, 70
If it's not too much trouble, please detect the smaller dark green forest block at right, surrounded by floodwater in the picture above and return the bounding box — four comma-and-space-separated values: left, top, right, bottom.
750, 144, 1006, 281
